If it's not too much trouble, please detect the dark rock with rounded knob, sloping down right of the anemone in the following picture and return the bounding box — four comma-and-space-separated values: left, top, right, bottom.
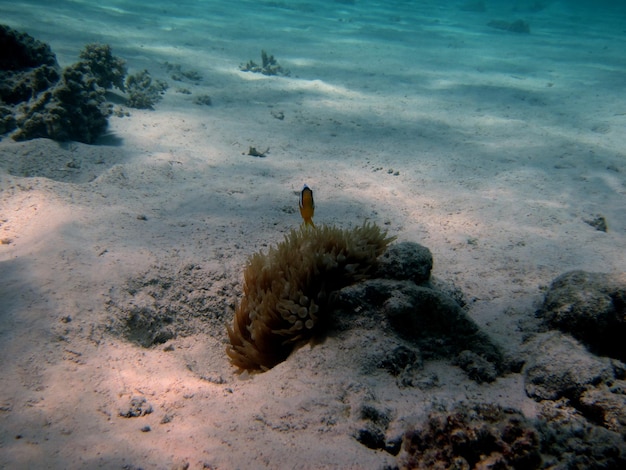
334, 246, 502, 383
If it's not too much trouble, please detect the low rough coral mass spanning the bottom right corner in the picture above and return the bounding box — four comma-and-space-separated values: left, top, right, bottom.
398, 401, 626, 470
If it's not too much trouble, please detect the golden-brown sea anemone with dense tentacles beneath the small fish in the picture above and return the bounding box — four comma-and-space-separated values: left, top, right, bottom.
227, 223, 393, 371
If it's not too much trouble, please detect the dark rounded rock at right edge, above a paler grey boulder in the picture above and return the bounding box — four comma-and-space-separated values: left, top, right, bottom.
538, 271, 626, 361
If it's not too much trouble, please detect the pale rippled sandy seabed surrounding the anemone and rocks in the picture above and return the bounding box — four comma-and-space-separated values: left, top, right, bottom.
0, 0, 626, 469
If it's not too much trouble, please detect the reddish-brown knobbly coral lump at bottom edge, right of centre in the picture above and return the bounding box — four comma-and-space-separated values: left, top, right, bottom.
399, 404, 541, 469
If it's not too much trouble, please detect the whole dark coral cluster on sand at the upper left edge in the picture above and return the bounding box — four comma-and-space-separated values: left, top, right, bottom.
0, 26, 124, 143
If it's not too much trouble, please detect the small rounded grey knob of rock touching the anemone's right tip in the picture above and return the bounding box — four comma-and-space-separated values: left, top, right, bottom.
376, 242, 433, 284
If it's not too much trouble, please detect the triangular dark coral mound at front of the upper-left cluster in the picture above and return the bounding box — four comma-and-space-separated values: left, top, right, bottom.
13, 63, 109, 144
